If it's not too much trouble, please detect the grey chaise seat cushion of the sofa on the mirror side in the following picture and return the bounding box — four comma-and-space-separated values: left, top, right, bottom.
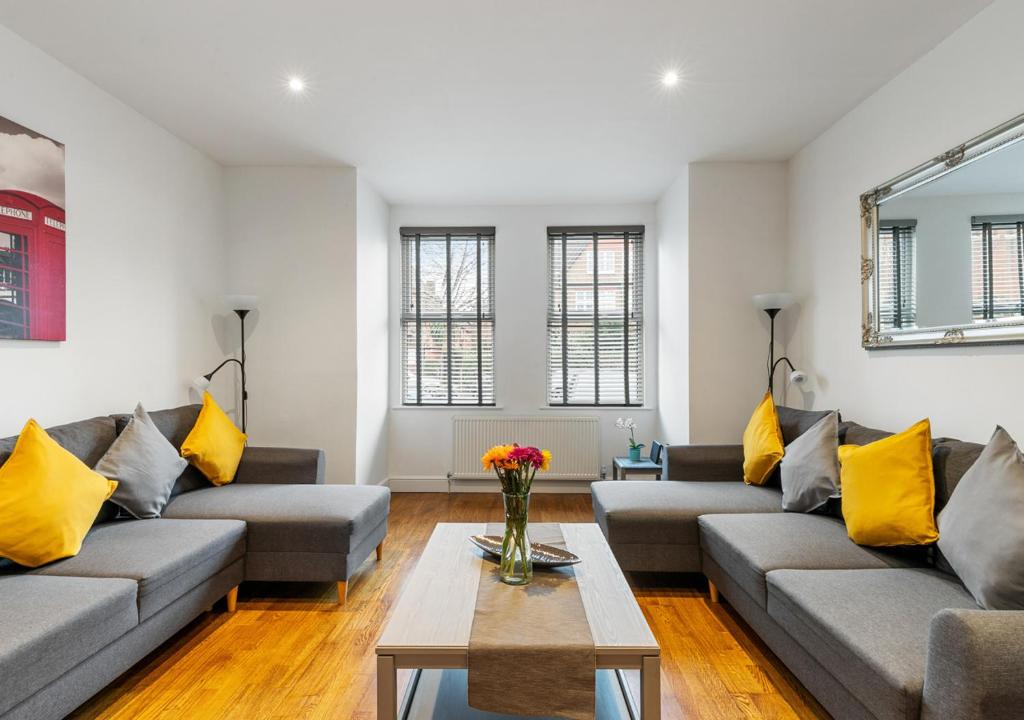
591, 480, 782, 546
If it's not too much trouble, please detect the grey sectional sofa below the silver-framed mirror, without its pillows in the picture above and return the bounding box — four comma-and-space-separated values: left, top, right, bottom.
592, 408, 1024, 720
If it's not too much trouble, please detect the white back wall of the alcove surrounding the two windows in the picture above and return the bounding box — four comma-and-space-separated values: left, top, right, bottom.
388, 204, 658, 489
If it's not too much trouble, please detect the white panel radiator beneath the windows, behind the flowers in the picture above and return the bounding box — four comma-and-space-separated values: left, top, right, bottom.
449, 417, 601, 482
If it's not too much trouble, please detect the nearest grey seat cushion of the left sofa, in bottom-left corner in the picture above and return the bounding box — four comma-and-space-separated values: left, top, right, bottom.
0, 575, 138, 715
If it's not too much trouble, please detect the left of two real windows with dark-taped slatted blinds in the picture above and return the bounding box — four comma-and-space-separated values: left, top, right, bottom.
401, 227, 495, 406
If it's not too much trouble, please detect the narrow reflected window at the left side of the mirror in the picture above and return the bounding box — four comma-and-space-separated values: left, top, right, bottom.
877, 220, 918, 330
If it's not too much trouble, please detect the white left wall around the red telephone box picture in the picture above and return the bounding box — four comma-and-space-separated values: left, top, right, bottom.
0, 27, 225, 435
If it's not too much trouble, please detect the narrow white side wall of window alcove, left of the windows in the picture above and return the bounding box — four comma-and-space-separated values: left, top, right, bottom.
355, 176, 390, 484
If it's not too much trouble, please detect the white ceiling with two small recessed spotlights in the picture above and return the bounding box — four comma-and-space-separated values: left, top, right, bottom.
0, 0, 990, 204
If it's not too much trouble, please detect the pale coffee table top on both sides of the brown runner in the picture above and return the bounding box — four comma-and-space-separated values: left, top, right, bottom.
377, 522, 658, 667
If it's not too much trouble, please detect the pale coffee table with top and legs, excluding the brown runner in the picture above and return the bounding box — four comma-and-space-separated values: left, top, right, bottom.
377, 522, 662, 720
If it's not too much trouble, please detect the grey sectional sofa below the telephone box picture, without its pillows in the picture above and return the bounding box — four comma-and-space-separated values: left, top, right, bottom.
0, 406, 390, 720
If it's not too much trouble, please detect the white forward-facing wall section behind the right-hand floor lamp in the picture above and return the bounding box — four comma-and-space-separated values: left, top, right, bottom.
688, 163, 801, 443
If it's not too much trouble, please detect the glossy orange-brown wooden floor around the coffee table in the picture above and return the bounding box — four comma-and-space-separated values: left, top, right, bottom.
73, 494, 828, 720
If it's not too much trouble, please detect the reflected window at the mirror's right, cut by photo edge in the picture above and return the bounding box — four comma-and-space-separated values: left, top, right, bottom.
971, 215, 1024, 323
